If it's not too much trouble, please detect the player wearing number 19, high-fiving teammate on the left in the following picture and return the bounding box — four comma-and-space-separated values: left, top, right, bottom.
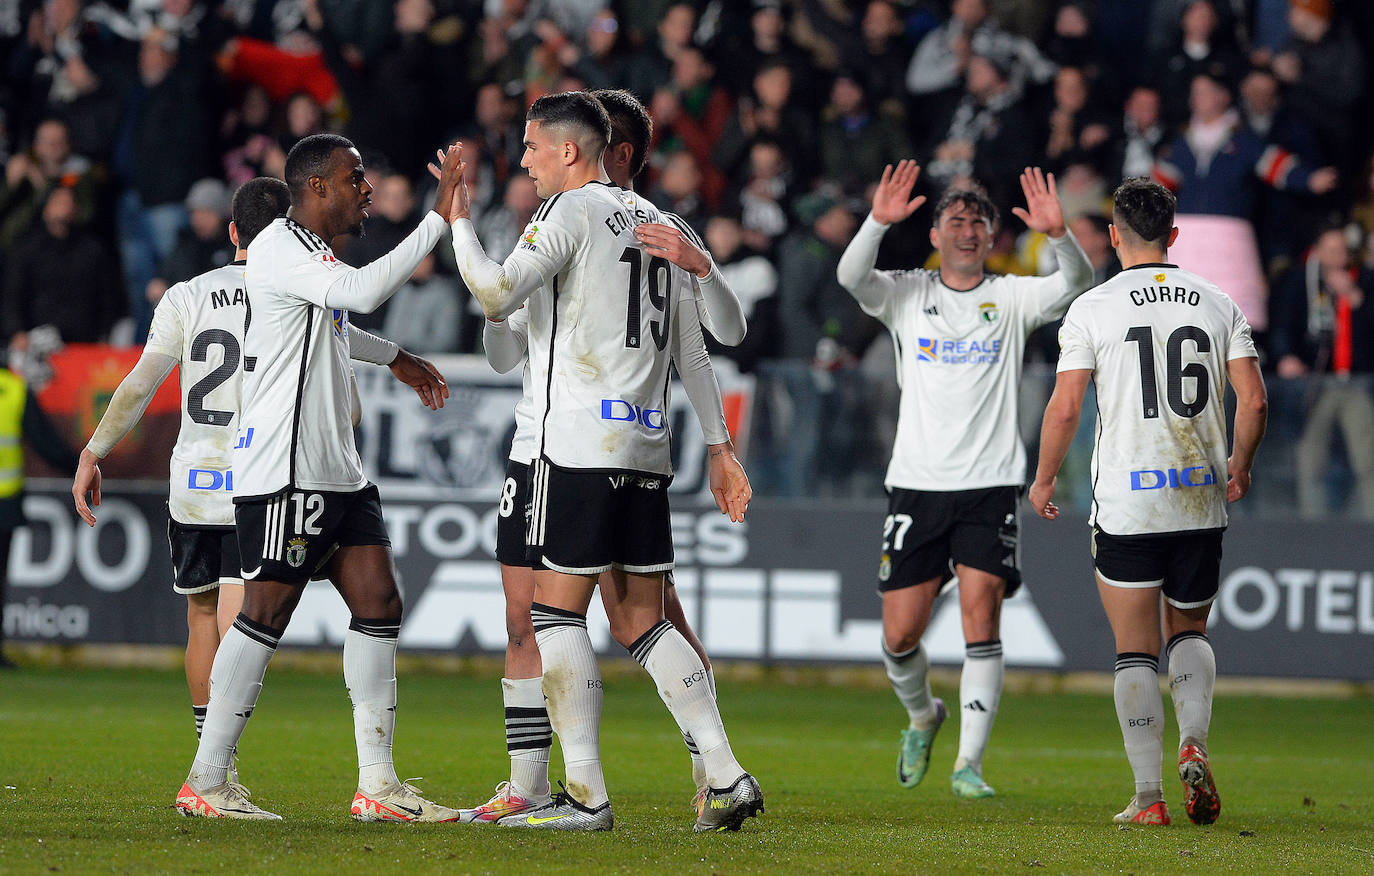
453, 92, 763, 831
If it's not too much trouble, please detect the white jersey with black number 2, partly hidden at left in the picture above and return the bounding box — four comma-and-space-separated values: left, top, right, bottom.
144, 262, 250, 526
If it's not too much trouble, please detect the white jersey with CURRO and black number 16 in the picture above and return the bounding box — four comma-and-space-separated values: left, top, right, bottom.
1058, 265, 1256, 535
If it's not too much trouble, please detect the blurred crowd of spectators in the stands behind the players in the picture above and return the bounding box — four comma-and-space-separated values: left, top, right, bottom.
0, 0, 1374, 501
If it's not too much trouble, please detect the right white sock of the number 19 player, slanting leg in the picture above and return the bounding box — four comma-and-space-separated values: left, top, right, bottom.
629, 621, 745, 788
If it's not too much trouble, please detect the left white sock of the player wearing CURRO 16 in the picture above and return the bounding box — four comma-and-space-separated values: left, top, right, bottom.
1112, 651, 1164, 807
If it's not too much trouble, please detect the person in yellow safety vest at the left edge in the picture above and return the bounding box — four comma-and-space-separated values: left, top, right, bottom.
0, 367, 77, 669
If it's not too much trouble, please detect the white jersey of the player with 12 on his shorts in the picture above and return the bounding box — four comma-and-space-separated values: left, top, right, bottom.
234, 218, 367, 501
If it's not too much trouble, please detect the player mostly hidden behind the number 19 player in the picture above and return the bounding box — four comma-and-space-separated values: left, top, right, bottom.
453, 89, 752, 824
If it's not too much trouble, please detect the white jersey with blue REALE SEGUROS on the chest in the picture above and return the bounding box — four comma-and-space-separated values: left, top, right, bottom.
864, 269, 1072, 490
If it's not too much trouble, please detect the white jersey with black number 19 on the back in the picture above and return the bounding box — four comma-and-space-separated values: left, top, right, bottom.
507, 183, 691, 475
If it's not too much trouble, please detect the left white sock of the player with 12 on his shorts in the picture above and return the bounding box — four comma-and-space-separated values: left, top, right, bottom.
187, 614, 282, 791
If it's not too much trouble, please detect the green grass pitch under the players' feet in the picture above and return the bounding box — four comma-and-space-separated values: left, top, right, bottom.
0, 667, 1374, 873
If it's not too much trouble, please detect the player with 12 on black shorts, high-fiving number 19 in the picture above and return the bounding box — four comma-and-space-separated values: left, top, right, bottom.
176, 135, 460, 821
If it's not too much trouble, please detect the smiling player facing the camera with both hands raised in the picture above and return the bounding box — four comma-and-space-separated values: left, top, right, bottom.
837, 161, 1092, 799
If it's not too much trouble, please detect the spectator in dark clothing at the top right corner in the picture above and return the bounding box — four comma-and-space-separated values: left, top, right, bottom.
1272, 0, 1367, 173
